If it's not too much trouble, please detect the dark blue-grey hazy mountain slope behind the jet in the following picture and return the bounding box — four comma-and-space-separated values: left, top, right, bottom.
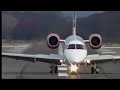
2, 11, 120, 41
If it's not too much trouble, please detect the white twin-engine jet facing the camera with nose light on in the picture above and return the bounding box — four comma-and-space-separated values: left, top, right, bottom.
2, 11, 120, 74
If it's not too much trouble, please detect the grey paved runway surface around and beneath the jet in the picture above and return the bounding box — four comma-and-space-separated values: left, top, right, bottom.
2, 42, 120, 79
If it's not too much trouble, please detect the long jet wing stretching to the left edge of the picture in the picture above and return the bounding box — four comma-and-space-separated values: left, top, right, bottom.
2, 53, 65, 64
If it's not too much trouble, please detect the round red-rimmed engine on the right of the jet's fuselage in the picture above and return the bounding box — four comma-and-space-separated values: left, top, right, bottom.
89, 34, 102, 49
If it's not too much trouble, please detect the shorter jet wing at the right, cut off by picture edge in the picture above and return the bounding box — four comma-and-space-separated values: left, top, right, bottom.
86, 54, 120, 64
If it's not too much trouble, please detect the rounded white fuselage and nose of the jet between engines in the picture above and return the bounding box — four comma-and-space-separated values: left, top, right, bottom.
64, 36, 87, 63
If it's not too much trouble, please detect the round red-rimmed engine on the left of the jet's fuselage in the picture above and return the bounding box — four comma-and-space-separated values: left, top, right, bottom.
47, 33, 60, 49
